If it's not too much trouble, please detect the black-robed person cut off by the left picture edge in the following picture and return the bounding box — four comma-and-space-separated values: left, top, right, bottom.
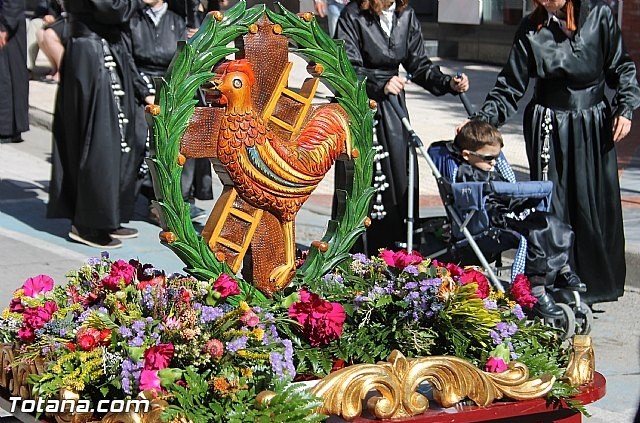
0, 0, 29, 142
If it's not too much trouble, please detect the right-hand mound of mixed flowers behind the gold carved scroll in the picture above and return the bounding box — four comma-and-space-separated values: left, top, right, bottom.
279, 250, 575, 398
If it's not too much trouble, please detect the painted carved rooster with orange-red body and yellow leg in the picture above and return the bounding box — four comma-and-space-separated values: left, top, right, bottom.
213, 59, 351, 288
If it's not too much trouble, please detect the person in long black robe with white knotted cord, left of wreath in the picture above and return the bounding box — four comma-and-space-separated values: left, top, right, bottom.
48, 0, 153, 248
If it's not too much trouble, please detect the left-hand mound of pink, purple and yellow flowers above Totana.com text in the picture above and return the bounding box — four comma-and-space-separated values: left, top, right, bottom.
0, 253, 320, 422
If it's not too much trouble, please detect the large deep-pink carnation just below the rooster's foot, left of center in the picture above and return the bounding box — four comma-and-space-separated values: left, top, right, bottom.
289, 289, 346, 347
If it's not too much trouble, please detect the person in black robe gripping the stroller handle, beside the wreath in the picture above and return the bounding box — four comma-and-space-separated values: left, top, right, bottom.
334, 0, 469, 254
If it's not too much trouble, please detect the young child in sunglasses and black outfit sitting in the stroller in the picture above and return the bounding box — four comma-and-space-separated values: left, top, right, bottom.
449, 121, 586, 318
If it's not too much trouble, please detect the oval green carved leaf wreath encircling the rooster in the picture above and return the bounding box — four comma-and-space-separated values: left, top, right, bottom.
149, 0, 374, 292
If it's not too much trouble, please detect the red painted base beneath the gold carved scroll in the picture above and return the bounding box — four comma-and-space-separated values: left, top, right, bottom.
354, 372, 607, 423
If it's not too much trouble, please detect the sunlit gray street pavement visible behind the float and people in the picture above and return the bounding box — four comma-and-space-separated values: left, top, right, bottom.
0, 54, 640, 423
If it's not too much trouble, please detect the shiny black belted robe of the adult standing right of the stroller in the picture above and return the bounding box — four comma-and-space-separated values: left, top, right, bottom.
478, 0, 640, 303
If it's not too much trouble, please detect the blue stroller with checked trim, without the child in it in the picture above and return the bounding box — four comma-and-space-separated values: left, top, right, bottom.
417, 141, 593, 338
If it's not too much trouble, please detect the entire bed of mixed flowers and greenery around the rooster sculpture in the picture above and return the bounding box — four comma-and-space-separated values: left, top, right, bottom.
0, 250, 575, 422
